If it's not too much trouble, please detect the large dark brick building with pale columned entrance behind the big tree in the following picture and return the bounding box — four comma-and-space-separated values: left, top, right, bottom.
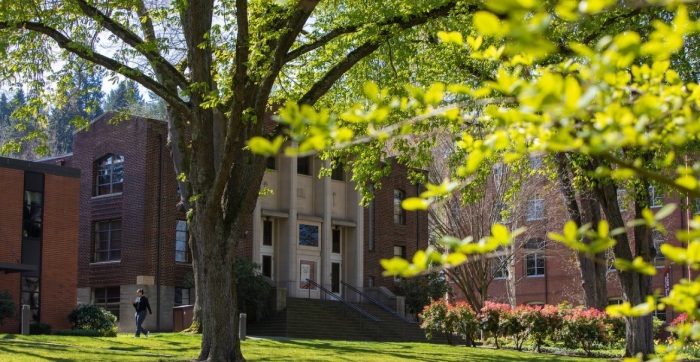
44, 114, 427, 332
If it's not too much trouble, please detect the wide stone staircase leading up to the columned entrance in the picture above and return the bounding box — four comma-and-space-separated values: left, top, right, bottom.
246, 298, 446, 343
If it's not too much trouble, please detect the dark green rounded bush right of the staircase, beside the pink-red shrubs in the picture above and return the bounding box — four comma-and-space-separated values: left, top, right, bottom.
399, 273, 450, 316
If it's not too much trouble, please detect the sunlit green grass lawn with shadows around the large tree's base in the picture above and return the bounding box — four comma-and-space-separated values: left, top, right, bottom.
0, 333, 604, 362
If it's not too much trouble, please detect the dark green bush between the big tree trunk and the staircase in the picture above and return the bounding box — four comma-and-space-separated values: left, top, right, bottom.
236, 257, 272, 321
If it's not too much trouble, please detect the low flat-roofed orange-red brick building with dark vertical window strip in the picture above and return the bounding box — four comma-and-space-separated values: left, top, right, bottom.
0, 157, 80, 333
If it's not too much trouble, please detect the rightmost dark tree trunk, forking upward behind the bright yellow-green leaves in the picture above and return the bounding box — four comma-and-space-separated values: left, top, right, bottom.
596, 180, 654, 358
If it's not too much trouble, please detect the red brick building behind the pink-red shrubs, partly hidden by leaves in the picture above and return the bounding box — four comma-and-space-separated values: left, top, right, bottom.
474, 159, 700, 322
